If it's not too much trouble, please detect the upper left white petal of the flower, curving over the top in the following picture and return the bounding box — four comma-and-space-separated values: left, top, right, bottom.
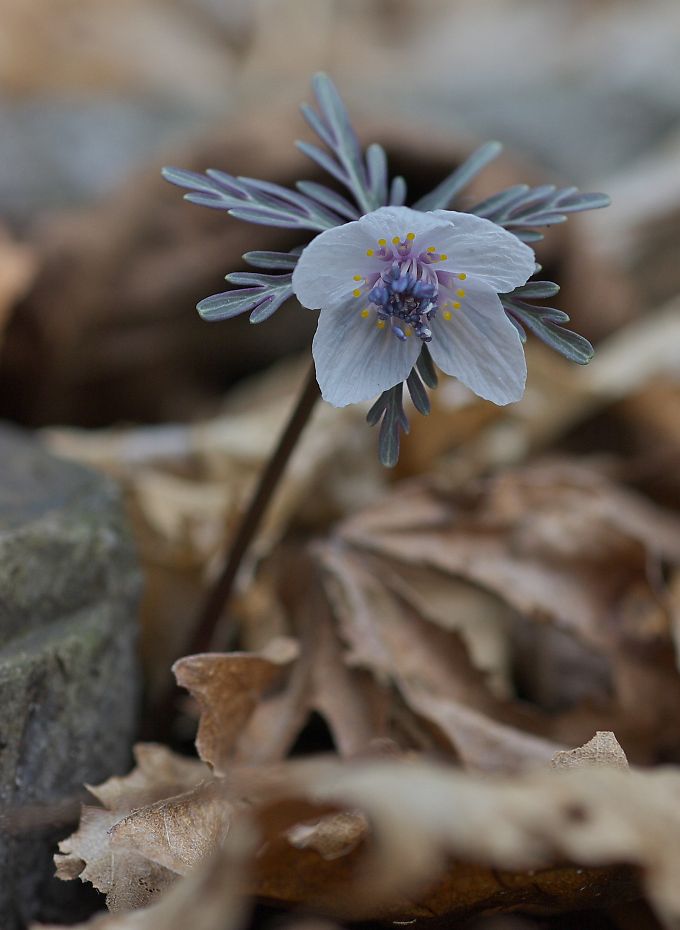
293, 207, 450, 310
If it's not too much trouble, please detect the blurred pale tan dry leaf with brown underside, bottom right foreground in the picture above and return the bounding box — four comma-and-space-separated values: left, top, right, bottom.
247, 762, 680, 927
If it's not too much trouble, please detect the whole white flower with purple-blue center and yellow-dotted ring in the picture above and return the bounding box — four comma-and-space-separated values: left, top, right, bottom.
292, 207, 536, 407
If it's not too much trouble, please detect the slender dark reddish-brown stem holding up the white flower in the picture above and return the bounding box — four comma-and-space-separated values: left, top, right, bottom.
187, 364, 319, 655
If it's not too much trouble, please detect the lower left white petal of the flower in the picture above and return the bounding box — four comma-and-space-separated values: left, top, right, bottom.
312, 302, 421, 407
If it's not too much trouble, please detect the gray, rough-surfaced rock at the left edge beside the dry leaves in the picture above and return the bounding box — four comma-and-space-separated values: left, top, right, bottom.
0, 426, 140, 930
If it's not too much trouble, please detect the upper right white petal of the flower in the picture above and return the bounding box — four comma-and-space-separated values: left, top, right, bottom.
431, 210, 536, 294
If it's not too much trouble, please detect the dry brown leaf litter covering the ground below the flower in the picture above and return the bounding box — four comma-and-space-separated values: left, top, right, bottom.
23, 34, 680, 930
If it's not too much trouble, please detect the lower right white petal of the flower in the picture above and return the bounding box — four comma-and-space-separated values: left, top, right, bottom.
430, 282, 527, 405
